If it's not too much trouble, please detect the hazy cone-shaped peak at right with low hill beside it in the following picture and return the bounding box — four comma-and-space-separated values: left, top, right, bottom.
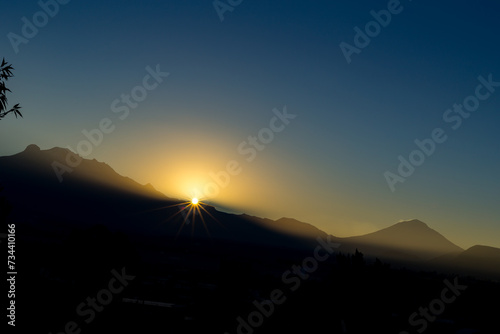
336, 219, 500, 280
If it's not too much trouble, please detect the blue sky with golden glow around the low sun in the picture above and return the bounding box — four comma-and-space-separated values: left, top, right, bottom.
0, 0, 500, 248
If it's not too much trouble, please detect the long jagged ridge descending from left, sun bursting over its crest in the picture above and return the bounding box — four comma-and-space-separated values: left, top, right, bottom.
0, 145, 326, 248
